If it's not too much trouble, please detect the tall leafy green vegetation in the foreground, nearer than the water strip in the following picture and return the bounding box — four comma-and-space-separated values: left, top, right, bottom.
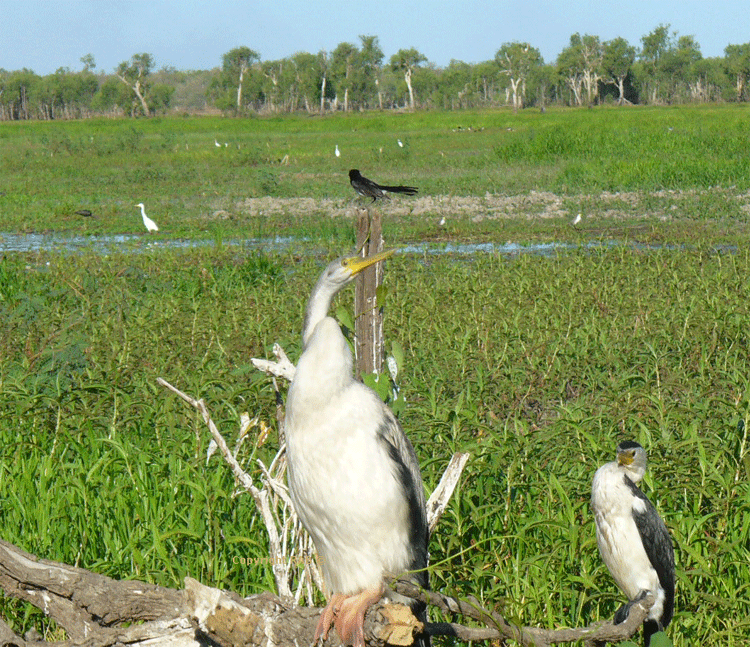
0, 249, 750, 645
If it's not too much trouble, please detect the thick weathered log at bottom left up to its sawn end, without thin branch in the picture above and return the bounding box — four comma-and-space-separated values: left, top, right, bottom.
0, 541, 422, 647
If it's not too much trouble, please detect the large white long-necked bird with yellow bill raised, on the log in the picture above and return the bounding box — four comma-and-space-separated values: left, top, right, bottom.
286, 252, 429, 647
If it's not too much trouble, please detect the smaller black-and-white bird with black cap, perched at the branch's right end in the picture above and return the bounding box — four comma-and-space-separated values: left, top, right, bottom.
591, 441, 675, 647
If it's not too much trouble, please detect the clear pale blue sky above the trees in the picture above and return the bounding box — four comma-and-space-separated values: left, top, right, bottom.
0, 0, 750, 74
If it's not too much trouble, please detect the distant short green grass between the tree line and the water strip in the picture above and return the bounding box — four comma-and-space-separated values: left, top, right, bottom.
0, 105, 750, 241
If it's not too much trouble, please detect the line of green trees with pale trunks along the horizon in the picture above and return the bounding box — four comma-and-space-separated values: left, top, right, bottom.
0, 25, 750, 120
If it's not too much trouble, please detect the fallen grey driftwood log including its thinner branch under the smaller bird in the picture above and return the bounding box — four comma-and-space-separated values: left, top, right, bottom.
0, 541, 654, 647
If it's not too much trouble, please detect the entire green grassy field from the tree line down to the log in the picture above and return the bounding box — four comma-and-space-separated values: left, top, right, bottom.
0, 108, 750, 647
